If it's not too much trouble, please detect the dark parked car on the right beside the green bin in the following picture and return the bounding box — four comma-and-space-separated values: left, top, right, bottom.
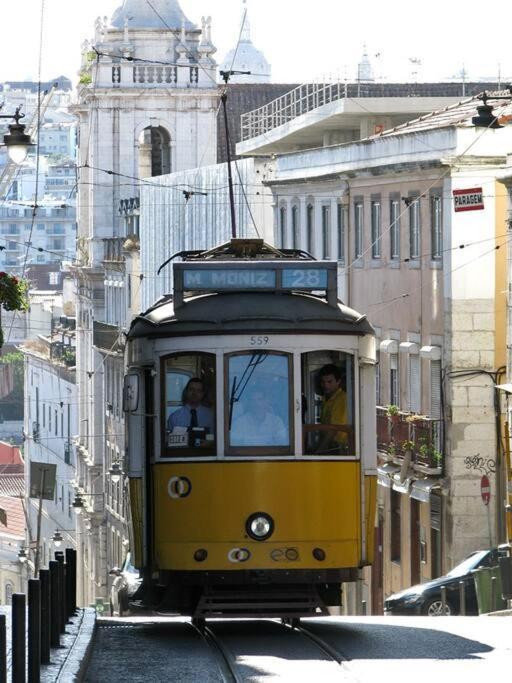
384, 548, 506, 617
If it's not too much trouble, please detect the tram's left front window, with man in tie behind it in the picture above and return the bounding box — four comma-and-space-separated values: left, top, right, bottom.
162, 353, 216, 457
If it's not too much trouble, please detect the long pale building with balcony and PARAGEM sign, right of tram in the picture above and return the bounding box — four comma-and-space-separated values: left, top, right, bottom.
240, 92, 512, 613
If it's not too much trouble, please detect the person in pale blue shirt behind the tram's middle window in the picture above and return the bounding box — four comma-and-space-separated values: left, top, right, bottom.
231, 389, 289, 447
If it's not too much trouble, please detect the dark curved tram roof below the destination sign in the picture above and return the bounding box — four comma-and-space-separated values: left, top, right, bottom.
128, 292, 374, 339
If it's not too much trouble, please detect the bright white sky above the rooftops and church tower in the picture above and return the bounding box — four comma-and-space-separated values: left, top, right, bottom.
0, 0, 512, 83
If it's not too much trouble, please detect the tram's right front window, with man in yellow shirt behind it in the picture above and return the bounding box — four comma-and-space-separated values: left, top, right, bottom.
302, 351, 355, 456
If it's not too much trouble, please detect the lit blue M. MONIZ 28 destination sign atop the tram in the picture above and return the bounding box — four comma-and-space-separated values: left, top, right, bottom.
183, 268, 328, 292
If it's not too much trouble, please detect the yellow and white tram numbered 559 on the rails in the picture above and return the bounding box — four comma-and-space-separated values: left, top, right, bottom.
125, 240, 376, 620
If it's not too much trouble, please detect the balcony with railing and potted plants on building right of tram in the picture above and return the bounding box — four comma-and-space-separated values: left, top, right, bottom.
377, 406, 443, 475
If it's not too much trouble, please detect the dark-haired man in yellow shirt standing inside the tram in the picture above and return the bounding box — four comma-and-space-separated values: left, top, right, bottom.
317, 363, 348, 453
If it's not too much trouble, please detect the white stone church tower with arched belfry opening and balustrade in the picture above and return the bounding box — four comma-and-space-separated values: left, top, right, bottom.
74, 0, 219, 604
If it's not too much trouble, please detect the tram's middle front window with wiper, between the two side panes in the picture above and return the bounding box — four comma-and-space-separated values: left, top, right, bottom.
226, 351, 293, 456
